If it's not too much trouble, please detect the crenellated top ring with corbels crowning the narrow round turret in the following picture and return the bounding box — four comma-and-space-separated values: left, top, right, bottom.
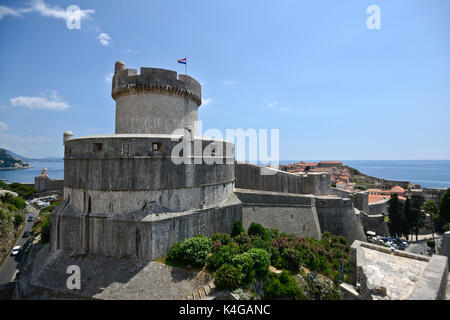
111, 61, 202, 106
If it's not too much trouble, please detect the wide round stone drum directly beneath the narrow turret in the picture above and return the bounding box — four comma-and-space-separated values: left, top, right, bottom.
64, 135, 234, 214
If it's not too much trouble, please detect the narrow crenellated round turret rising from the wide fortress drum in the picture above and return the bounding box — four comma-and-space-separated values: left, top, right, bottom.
112, 61, 201, 134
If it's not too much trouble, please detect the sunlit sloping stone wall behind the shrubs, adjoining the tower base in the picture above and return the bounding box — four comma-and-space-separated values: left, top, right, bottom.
235, 189, 321, 239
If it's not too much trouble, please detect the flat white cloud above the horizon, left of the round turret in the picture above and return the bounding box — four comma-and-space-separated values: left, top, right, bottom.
9, 90, 70, 111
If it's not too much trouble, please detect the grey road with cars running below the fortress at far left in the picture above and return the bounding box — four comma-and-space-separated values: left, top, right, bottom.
0, 205, 39, 285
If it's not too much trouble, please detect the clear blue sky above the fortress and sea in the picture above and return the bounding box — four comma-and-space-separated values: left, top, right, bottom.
0, 0, 450, 160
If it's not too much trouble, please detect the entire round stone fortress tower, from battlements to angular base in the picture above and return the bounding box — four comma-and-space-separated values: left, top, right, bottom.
51, 62, 242, 260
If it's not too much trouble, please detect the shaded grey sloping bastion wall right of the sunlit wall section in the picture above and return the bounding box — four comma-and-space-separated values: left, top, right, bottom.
316, 196, 366, 243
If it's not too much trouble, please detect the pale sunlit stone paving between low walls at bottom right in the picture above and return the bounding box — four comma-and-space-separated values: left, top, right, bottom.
361, 247, 427, 300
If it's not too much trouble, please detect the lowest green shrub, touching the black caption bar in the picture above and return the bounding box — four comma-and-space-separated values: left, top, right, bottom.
264, 271, 305, 300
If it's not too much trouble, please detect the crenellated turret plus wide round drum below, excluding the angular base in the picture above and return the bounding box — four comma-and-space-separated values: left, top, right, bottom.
64, 61, 234, 215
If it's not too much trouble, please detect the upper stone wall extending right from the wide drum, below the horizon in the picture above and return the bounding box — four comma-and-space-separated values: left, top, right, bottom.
235, 162, 331, 195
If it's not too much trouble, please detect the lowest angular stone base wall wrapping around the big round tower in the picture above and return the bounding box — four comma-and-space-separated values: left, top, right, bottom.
50, 194, 242, 261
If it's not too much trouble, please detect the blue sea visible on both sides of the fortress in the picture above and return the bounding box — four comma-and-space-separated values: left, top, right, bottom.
0, 160, 450, 188
